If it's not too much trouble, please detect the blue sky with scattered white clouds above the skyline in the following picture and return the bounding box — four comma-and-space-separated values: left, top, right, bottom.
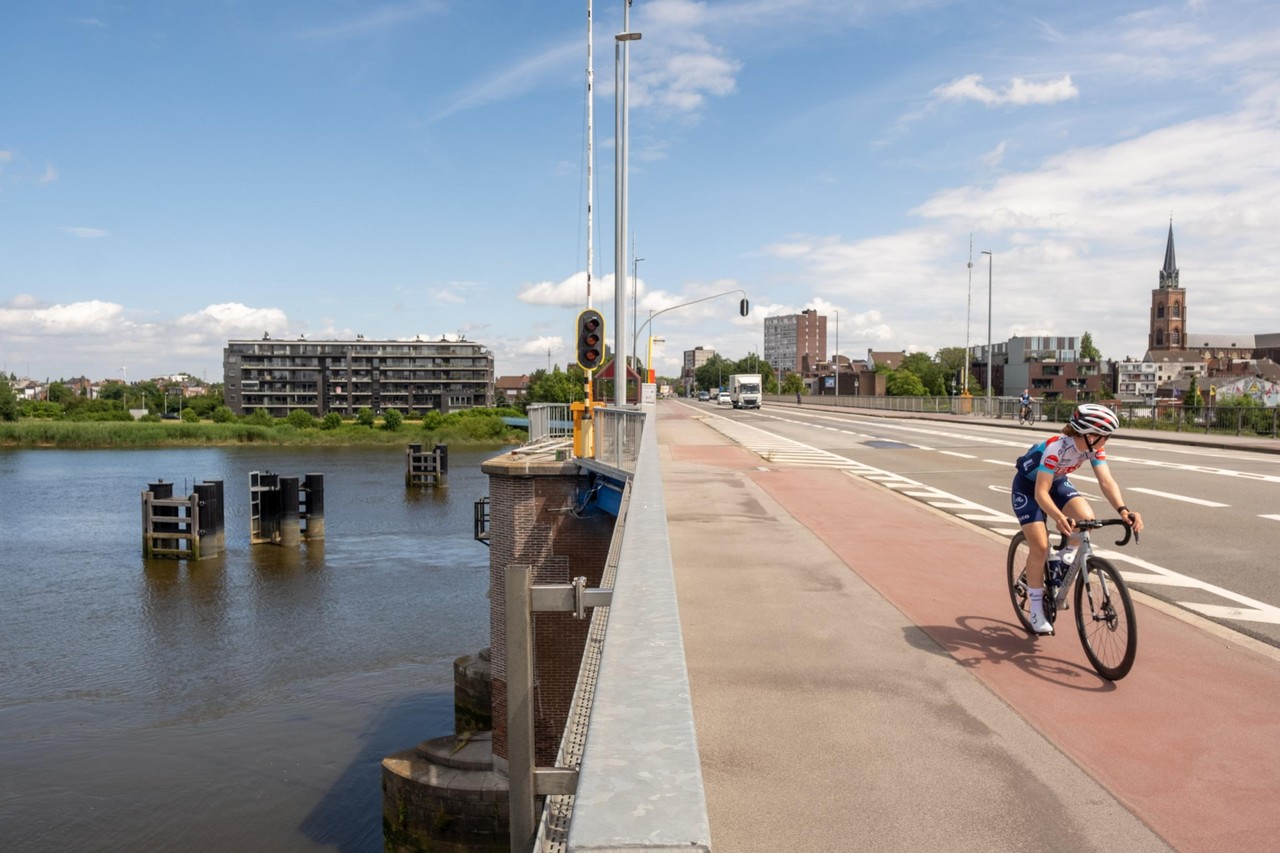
0, 0, 1280, 380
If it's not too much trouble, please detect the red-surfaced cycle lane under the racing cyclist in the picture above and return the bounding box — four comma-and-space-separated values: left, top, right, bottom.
748, 469, 1280, 850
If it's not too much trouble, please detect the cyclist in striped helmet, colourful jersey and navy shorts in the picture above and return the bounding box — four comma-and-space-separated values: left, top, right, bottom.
1012, 403, 1142, 634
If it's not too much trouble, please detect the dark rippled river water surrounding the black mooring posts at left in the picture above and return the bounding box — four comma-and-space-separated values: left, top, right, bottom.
0, 447, 498, 850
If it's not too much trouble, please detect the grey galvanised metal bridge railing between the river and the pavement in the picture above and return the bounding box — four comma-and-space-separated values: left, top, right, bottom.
507, 407, 712, 853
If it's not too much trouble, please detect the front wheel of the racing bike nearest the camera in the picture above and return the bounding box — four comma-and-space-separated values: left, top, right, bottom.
1075, 557, 1138, 681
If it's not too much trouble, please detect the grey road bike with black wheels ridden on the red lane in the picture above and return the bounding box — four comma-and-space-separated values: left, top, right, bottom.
1009, 519, 1138, 681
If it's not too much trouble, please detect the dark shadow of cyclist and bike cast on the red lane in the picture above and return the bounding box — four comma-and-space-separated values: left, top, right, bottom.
904, 616, 1116, 693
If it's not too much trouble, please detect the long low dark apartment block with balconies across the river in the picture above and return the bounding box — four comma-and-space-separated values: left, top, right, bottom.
223, 336, 494, 418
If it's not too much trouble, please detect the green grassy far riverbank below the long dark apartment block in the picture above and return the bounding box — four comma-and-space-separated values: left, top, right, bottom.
0, 418, 525, 450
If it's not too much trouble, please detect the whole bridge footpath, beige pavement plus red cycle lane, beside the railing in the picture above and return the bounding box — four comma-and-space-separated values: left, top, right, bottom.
658, 402, 1280, 853
